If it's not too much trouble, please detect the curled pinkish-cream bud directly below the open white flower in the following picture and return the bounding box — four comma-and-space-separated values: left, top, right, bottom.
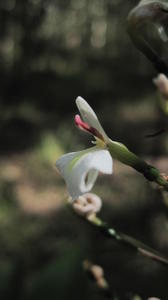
72, 193, 102, 218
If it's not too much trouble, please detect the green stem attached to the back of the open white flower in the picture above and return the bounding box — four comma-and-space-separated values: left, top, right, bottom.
108, 140, 168, 191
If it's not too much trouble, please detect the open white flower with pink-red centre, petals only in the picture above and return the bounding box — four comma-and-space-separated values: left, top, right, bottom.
56, 97, 113, 200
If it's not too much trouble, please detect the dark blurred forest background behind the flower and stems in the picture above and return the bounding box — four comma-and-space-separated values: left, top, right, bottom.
0, 0, 168, 300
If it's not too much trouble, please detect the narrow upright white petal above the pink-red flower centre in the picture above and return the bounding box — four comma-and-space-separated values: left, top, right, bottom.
76, 96, 109, 141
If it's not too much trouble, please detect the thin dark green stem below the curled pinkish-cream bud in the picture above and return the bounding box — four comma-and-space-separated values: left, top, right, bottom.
88, 216, 168, 265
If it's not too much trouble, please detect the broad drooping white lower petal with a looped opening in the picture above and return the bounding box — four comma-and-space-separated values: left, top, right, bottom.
56, 147, 112, 200
